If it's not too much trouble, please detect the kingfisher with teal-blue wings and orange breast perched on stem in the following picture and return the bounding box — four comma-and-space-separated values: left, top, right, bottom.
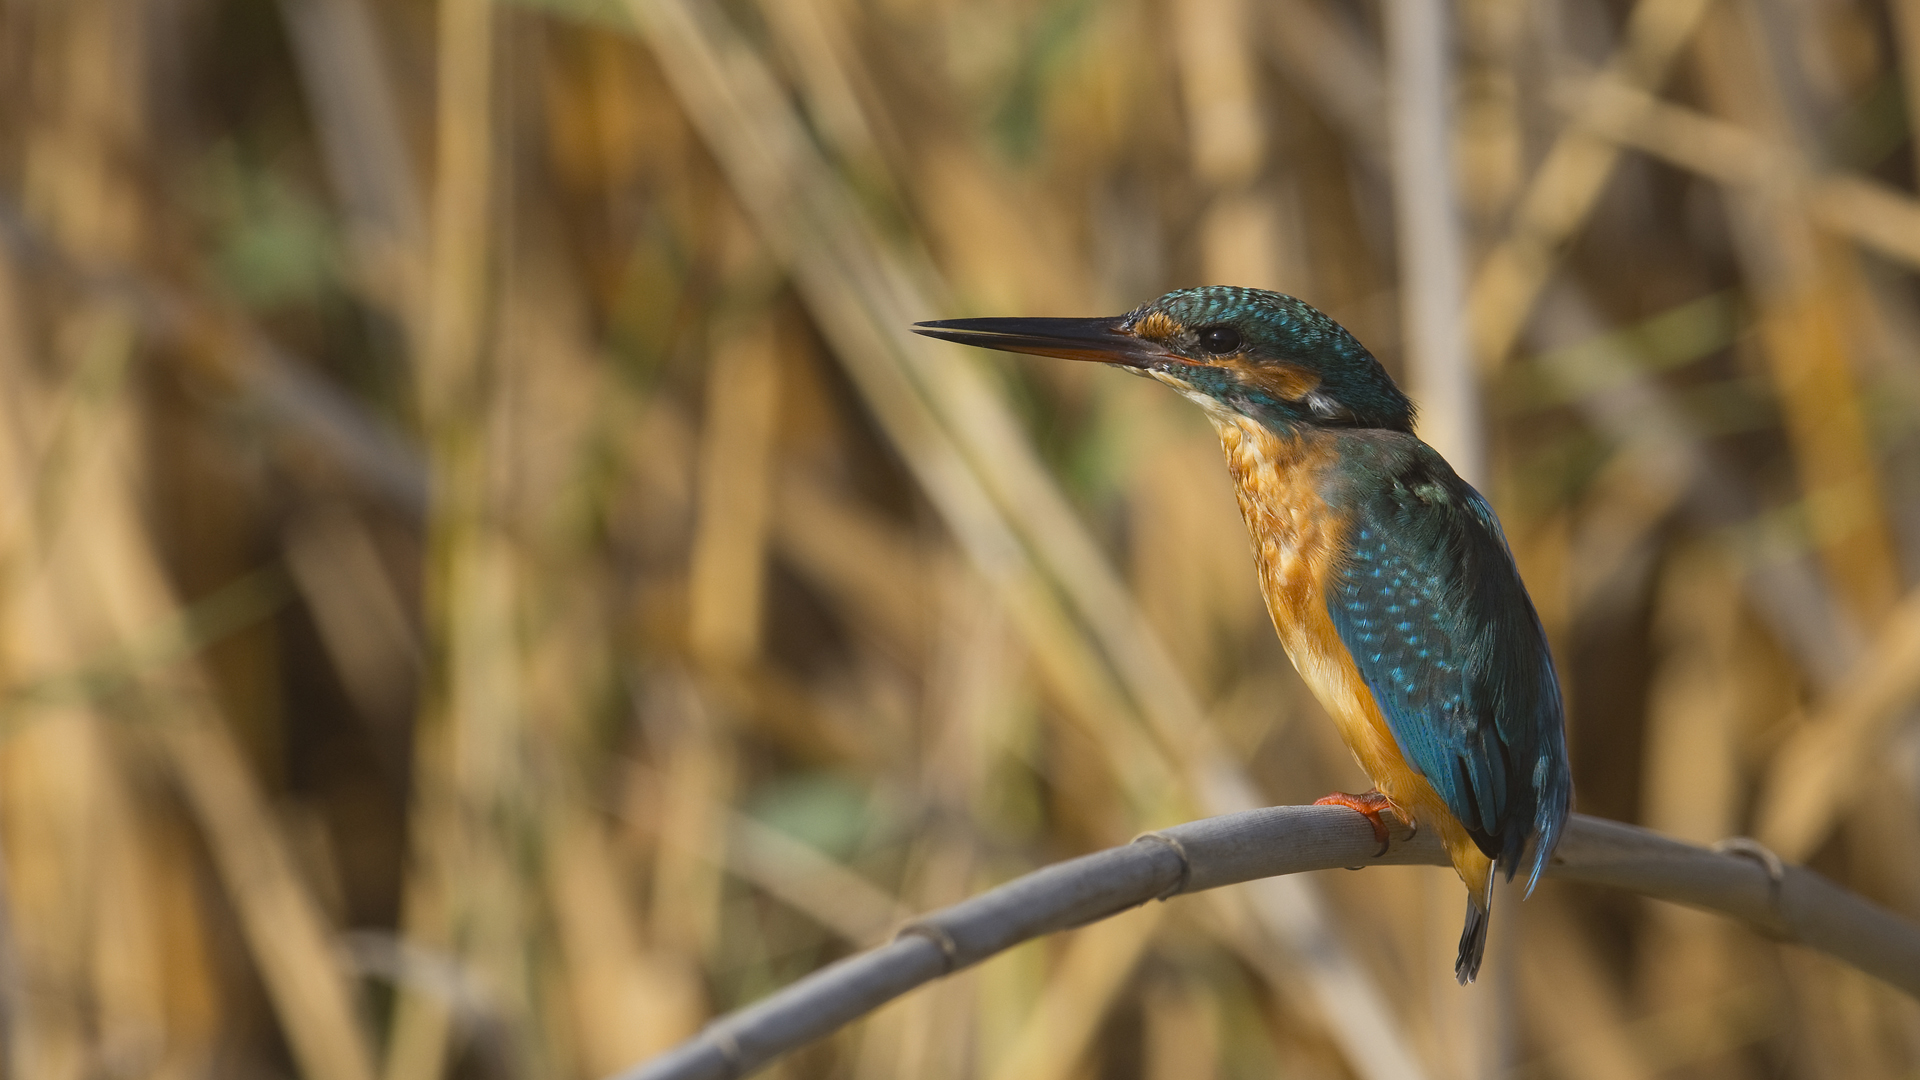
914, 286, 1572, 986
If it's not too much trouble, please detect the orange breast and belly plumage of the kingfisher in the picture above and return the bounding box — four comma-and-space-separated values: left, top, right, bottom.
1212, 413, 1490, 896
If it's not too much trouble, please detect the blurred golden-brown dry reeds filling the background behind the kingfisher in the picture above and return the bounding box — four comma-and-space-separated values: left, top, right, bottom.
0, 0, 1920, 1080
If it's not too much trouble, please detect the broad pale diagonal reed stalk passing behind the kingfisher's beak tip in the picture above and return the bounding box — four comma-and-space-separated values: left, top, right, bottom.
636, 4, 1443, 1074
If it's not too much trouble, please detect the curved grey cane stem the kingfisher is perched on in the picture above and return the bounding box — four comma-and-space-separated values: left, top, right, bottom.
614, 807, 1920, 1080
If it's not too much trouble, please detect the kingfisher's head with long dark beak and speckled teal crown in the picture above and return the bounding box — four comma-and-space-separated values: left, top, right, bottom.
914, 284, 1413, 432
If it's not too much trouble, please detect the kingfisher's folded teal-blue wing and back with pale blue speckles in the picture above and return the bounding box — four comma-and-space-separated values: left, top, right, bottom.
1327, 430, 1572, 892
